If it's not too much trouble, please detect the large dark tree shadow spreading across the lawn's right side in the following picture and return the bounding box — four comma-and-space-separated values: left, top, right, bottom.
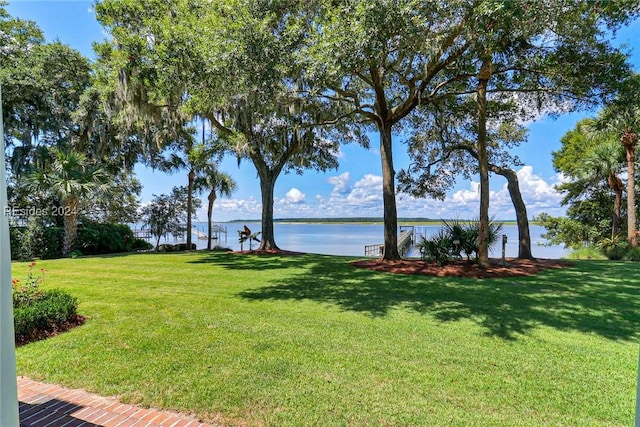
238, 256, 640, 340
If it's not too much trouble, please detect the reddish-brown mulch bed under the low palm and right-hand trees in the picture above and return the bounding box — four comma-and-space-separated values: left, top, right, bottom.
351, 258, 575, 279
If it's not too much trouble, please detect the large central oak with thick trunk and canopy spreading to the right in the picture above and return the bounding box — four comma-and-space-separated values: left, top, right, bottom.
309, 0, 637, 259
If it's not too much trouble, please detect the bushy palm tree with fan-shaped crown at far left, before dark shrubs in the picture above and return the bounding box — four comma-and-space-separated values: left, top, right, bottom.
27, 148, 108, 256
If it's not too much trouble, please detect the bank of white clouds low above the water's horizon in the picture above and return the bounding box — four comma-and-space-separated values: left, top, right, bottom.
194, 166, 565, 221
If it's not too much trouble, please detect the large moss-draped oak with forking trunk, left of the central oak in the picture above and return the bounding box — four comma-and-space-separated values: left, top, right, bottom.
96, 0, 348, 250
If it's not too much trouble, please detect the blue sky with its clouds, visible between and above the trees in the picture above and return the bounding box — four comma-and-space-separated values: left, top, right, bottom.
7, 0, 640, 221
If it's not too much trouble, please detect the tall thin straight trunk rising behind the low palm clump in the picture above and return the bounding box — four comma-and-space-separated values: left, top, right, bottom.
477, 61, 491, 268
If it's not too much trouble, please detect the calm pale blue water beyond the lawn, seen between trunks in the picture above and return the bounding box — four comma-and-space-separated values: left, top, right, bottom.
175, 222, 568, 258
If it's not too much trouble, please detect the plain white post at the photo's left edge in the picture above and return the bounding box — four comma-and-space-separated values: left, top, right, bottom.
0, 87, 20, 427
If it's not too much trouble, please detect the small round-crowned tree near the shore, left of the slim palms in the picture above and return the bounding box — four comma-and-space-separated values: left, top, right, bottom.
141, 187, 201, 250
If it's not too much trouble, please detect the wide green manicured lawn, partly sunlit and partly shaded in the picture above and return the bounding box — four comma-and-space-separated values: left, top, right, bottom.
13, 252, 640, 426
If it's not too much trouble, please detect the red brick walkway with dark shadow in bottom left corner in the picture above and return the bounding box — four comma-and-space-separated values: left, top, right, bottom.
18, 377, 213, 427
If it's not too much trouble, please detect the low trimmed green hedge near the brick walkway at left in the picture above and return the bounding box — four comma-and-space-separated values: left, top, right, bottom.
13, 289, 78, 343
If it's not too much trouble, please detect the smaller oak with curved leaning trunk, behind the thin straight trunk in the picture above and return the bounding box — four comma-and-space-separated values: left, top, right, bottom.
398, 98, 533, 259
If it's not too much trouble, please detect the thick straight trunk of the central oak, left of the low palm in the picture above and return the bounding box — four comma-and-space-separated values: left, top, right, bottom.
379, 125, 400, 261
